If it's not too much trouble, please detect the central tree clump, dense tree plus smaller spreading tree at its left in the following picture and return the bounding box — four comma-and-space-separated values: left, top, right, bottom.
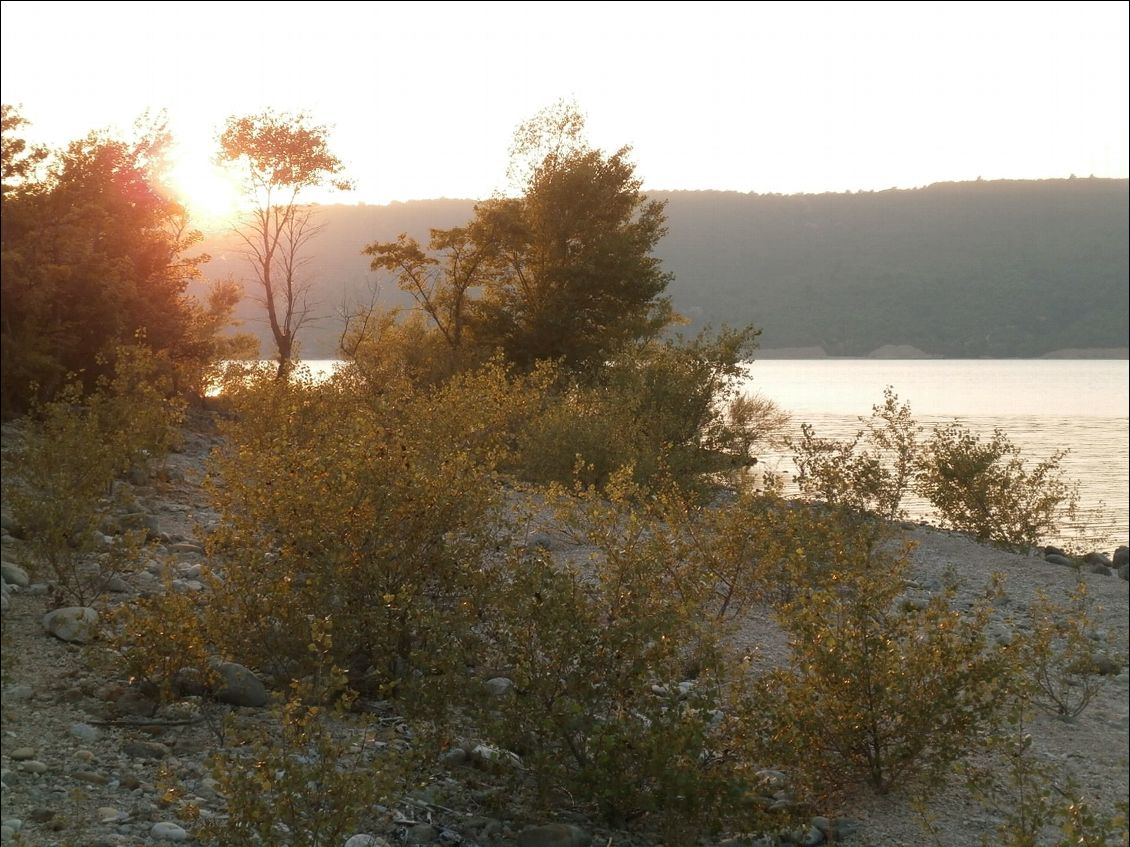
364, 104, 672, 370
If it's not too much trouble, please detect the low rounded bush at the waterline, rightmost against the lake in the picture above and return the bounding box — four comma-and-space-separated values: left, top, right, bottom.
916, 422, 1078, 550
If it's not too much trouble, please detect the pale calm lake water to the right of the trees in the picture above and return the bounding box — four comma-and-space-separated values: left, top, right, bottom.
745, 359, 1130, 552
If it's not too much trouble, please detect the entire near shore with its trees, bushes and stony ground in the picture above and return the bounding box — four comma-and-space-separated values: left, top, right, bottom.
0, 104, 1130, 847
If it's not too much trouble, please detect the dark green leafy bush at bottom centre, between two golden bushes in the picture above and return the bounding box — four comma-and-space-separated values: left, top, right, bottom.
472, 472, 772, 842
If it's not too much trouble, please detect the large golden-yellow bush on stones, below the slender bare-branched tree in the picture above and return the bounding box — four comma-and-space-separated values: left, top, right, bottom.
197, 370, 513, 691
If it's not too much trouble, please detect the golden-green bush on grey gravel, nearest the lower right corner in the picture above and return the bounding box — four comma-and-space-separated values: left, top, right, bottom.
751, 512, 1010, 794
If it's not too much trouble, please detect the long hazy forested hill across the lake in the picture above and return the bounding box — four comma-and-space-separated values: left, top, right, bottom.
198, 178, 1130, 357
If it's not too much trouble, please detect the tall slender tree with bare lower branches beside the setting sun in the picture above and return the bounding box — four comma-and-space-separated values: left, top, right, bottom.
219, 111, 351, 376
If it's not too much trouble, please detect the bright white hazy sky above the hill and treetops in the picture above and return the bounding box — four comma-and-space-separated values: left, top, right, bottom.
0, 0, 1130, 202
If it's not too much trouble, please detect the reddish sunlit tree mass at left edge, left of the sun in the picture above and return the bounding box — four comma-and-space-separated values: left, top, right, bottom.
0, 107, 212, 413
